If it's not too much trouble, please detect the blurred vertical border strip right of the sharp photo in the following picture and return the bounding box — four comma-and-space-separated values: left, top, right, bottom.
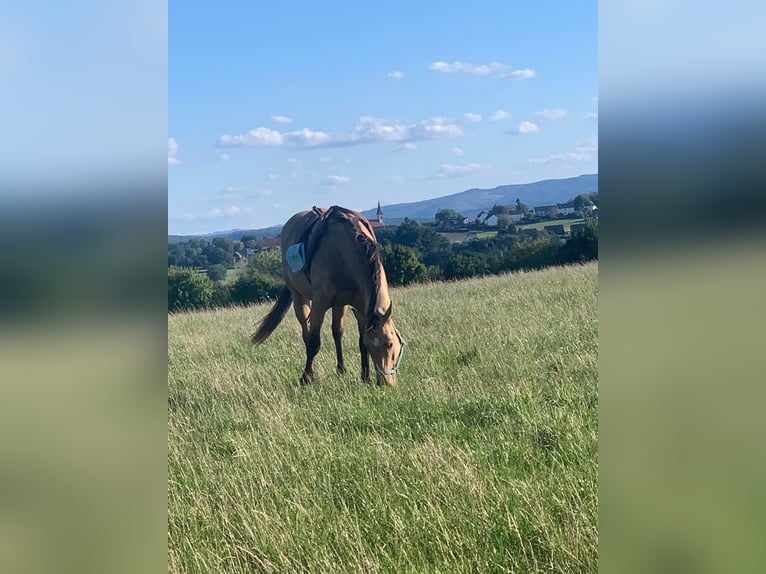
599, 0, 766, 573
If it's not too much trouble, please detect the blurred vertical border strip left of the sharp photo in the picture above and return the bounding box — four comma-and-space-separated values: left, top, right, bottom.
0, 0, 167, 573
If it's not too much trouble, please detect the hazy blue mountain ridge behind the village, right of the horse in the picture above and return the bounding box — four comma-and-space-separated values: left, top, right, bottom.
362, 173, 598, 223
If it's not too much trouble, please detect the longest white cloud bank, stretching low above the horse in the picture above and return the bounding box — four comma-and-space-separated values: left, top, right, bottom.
217, 116, 463, 149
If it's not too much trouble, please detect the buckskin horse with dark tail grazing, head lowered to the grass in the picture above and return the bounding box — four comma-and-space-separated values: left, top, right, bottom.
252, 206, 406, 385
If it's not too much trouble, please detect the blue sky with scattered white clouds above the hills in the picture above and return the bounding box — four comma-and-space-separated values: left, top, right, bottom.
168, 0, 598, 234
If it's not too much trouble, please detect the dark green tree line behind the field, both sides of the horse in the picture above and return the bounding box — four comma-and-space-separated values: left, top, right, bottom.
168, 208, 598, 311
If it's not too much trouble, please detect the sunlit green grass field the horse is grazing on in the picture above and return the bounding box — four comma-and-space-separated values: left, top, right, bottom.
168, 263, 598, 573
